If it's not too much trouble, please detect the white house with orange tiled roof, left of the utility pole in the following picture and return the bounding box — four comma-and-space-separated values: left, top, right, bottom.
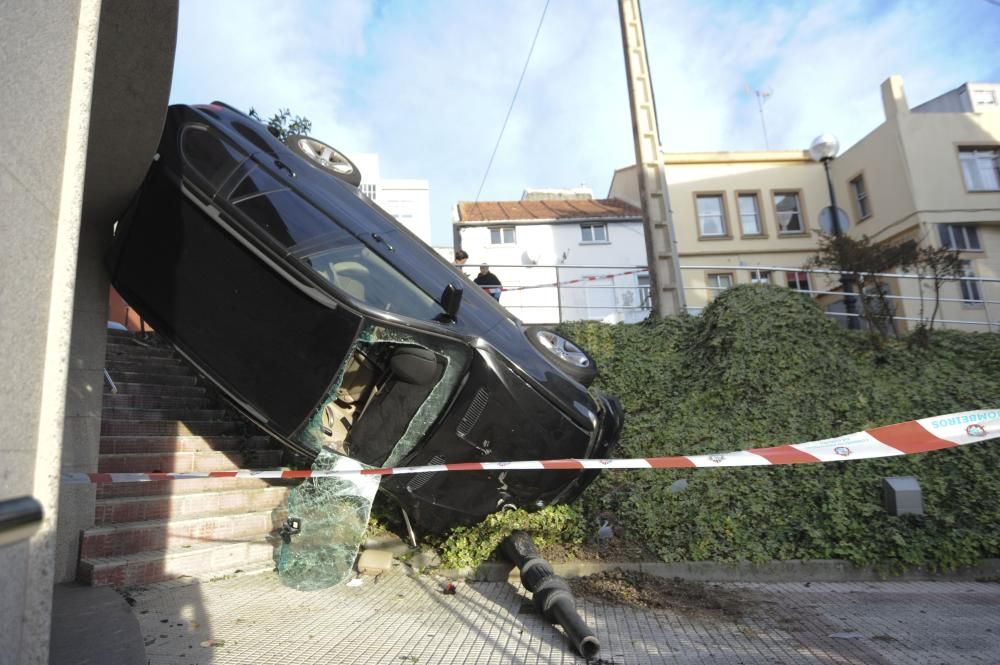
453, 196, 649, 323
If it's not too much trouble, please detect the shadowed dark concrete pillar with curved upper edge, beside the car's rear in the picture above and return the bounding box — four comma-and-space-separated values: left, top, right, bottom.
56, 0, 177, 582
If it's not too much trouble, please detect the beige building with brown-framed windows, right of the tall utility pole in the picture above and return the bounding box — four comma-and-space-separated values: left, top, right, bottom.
609, 76, 1000, 331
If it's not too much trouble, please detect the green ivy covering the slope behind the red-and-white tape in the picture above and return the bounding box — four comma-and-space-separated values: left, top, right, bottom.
562, 285, 1000, 571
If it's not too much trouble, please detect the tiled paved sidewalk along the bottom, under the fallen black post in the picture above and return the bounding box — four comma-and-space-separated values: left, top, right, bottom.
132, 567, 1000, 665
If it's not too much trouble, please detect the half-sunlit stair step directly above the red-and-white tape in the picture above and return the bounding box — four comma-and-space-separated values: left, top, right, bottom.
97, 450, 282, 474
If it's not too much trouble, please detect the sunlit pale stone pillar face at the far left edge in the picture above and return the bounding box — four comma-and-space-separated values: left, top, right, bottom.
0, 0, 100, 665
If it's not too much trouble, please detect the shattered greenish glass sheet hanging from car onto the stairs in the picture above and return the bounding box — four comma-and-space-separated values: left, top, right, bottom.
278, 450, 380, 591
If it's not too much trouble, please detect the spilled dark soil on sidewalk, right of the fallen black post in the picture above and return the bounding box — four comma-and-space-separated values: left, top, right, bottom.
568, 570, 753, 621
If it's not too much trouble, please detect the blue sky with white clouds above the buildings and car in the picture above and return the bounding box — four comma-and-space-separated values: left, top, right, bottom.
170, 0, 1000, 246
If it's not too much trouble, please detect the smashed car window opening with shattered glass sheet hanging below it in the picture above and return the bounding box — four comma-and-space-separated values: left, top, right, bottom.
278, 326, 471, 591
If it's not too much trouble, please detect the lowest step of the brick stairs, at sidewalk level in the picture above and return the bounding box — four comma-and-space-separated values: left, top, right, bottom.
77, 539, 275, 588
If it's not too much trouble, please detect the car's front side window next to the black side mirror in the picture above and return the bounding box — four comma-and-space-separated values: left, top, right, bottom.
292, 239, 444, 321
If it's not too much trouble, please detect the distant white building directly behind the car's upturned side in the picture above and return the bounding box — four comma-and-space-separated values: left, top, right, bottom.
351, 153, 431, 245
